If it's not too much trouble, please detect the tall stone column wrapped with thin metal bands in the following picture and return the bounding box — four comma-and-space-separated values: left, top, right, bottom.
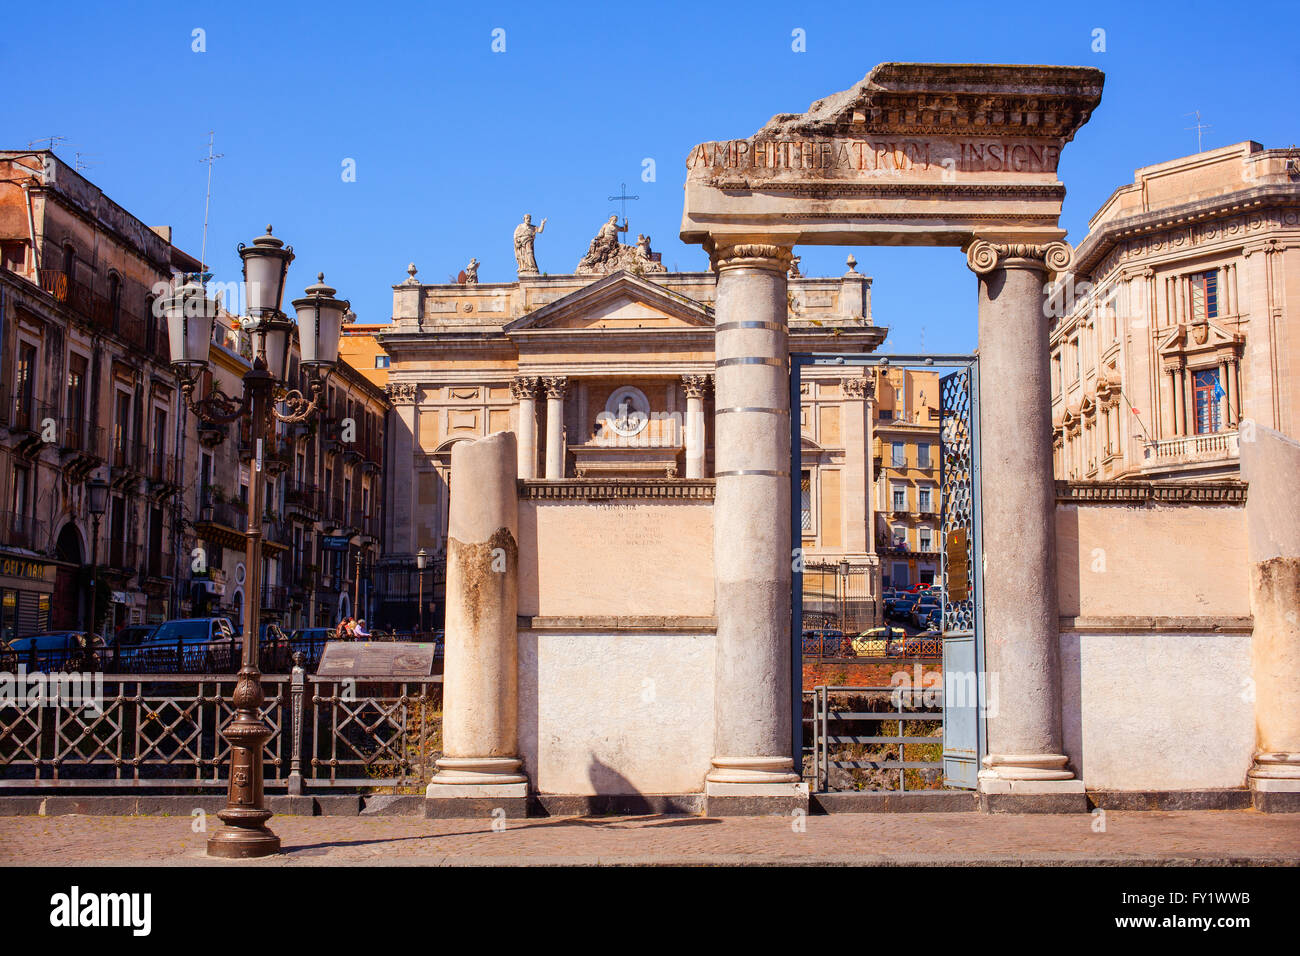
706, 243, 807, 814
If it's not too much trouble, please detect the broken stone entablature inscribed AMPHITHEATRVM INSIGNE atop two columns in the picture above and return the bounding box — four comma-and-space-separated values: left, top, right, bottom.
681, 64, 1102, 248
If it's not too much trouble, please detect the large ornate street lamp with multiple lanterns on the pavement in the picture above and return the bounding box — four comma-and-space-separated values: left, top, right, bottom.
163, 226, 348, 858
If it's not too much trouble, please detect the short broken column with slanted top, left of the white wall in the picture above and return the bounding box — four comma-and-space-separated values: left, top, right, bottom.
426, 432, 528, 817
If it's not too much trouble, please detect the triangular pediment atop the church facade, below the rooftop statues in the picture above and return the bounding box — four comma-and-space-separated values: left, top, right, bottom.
504, 272, 714, 336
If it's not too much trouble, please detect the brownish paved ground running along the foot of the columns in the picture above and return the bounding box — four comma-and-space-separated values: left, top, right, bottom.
0, 810, 1300, 866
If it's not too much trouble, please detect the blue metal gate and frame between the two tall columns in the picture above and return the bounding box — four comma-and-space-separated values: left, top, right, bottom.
790, 354, 987, 788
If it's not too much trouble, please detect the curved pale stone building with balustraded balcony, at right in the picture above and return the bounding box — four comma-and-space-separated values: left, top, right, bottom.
1050, 142, 1300, 480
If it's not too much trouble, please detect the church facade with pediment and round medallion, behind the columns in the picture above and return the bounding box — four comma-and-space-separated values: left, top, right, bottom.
377, 243, 887, 624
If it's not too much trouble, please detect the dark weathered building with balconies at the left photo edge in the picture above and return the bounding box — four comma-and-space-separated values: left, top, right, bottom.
0, 150, 199, 639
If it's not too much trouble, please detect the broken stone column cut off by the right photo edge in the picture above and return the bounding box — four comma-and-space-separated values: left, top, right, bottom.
1242, 425, 1300, 812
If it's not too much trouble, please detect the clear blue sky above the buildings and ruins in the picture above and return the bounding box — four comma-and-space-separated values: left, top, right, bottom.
0, 1, 1300, 351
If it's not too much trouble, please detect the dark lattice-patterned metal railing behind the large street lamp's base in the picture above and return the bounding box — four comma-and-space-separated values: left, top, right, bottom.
0, 666, 442, 793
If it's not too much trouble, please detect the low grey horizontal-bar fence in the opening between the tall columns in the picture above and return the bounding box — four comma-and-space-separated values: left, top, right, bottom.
810, 685, 944, 793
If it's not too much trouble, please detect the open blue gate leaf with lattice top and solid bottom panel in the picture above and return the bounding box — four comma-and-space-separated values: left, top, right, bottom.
939, 362, 984, 788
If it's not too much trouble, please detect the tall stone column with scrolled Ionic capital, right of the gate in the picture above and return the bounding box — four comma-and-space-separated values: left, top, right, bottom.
967, 239, 1087, 810
